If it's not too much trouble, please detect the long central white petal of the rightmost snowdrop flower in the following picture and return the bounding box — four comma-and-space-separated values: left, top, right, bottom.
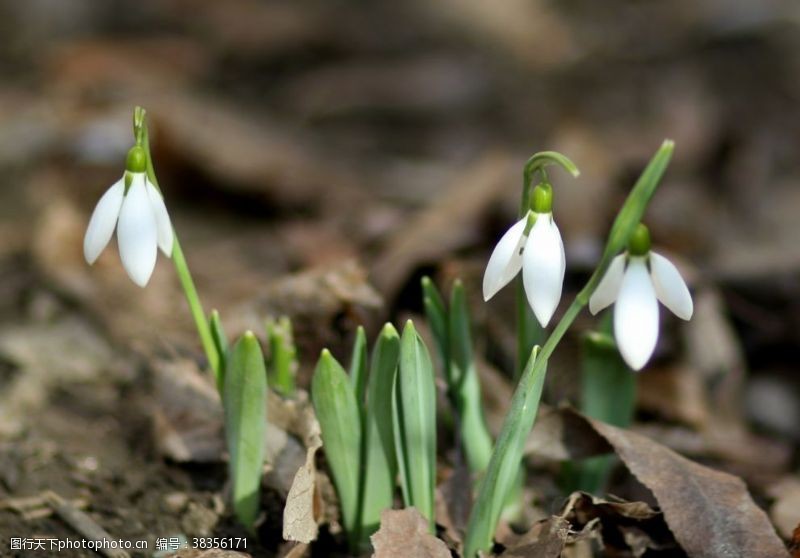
614, 258, 658, 370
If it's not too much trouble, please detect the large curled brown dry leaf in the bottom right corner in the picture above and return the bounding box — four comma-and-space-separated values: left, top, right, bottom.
528, 409, 787, 558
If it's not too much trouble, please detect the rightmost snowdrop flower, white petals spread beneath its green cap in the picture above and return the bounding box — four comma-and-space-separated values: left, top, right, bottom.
589, 224, 694, 370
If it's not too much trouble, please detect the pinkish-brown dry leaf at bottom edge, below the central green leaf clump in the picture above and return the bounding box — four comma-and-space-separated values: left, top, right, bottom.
370, 508, 450, 558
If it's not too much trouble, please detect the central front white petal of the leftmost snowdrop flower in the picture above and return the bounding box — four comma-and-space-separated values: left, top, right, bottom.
117, 176, 158, 287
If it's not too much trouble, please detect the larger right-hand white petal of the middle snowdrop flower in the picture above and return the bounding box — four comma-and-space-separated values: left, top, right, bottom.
522, 215, 565, 327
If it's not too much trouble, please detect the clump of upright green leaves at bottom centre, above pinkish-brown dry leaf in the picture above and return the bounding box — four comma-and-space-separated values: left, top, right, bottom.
311, 321, 436, 549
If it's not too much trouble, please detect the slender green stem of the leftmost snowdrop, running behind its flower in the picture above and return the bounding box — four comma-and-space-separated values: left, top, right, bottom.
133, 107, 222, 385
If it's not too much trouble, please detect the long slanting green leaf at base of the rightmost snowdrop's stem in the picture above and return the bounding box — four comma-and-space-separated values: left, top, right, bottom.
464, 347, 547, 558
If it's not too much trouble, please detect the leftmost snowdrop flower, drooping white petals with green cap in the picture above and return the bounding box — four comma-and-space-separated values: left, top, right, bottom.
83, 146, 173, 287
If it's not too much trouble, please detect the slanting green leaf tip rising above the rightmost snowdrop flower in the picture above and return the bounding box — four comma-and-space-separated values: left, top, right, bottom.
604, 140, 675, 257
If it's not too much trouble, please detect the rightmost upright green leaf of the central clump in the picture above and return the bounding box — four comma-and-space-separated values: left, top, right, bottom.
393, 320, 436, 532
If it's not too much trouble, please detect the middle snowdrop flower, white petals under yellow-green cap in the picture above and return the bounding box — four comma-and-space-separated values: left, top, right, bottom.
483, 183, 565, 327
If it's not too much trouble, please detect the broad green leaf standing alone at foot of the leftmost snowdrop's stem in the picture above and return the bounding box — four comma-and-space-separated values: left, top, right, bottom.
223, 331, 267, 532
